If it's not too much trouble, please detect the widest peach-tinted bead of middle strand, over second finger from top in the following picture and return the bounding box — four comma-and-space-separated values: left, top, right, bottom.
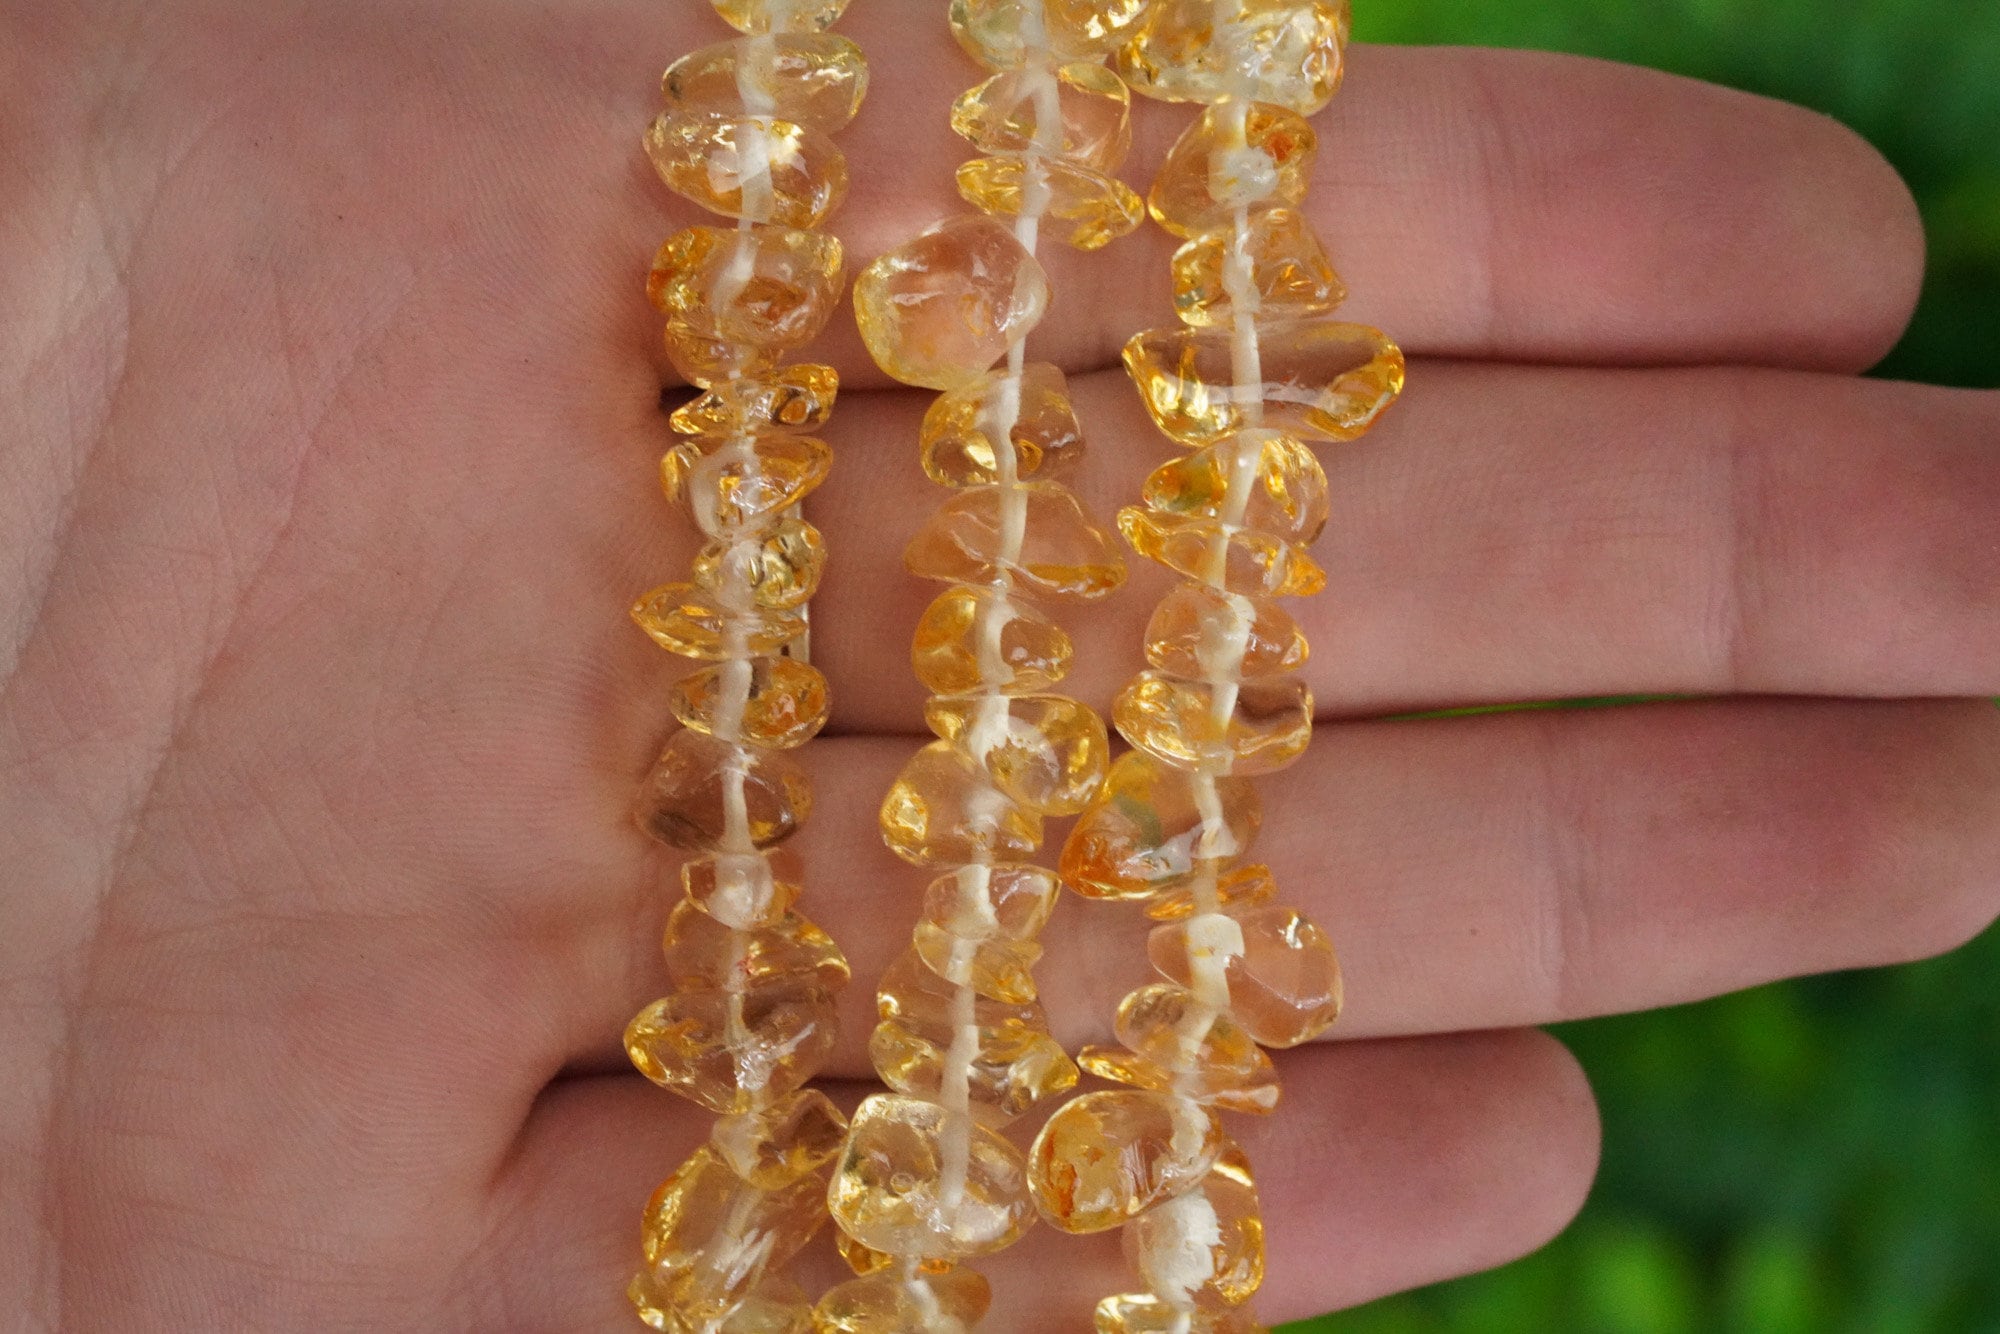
902, 482, 1126, 602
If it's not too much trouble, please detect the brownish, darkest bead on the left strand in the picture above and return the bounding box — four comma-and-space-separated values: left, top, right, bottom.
636, 728, 812, 852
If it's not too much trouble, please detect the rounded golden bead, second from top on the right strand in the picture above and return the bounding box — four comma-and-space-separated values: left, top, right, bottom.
1146, 104, 1320, 238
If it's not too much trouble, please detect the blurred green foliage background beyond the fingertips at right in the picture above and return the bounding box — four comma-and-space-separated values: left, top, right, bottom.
1288, 0, 2000, 1334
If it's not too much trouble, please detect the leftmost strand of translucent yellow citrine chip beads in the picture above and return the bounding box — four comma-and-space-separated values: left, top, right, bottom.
624, 0, 868, 1334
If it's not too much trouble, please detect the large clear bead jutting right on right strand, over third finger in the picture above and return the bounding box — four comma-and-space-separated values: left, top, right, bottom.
1146, 904, 1340, 1046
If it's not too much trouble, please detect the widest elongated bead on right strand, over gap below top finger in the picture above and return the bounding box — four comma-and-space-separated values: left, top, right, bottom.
1124, 320, 1404, 444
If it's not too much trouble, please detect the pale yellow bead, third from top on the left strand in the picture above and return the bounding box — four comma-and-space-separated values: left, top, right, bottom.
646, 112, 848, 228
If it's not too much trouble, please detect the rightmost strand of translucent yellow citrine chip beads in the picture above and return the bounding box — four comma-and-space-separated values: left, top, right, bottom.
1030, 0, 1404, 1334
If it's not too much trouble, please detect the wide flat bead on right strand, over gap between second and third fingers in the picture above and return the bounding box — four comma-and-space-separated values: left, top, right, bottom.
1112, 668, 1312, 778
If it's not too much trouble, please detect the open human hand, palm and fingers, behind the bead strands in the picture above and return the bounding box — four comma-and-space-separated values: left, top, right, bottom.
0, 0, 2000, 1332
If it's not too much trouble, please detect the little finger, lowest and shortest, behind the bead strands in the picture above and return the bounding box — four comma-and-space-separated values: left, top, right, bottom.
480, 1032, 1598, 1334
